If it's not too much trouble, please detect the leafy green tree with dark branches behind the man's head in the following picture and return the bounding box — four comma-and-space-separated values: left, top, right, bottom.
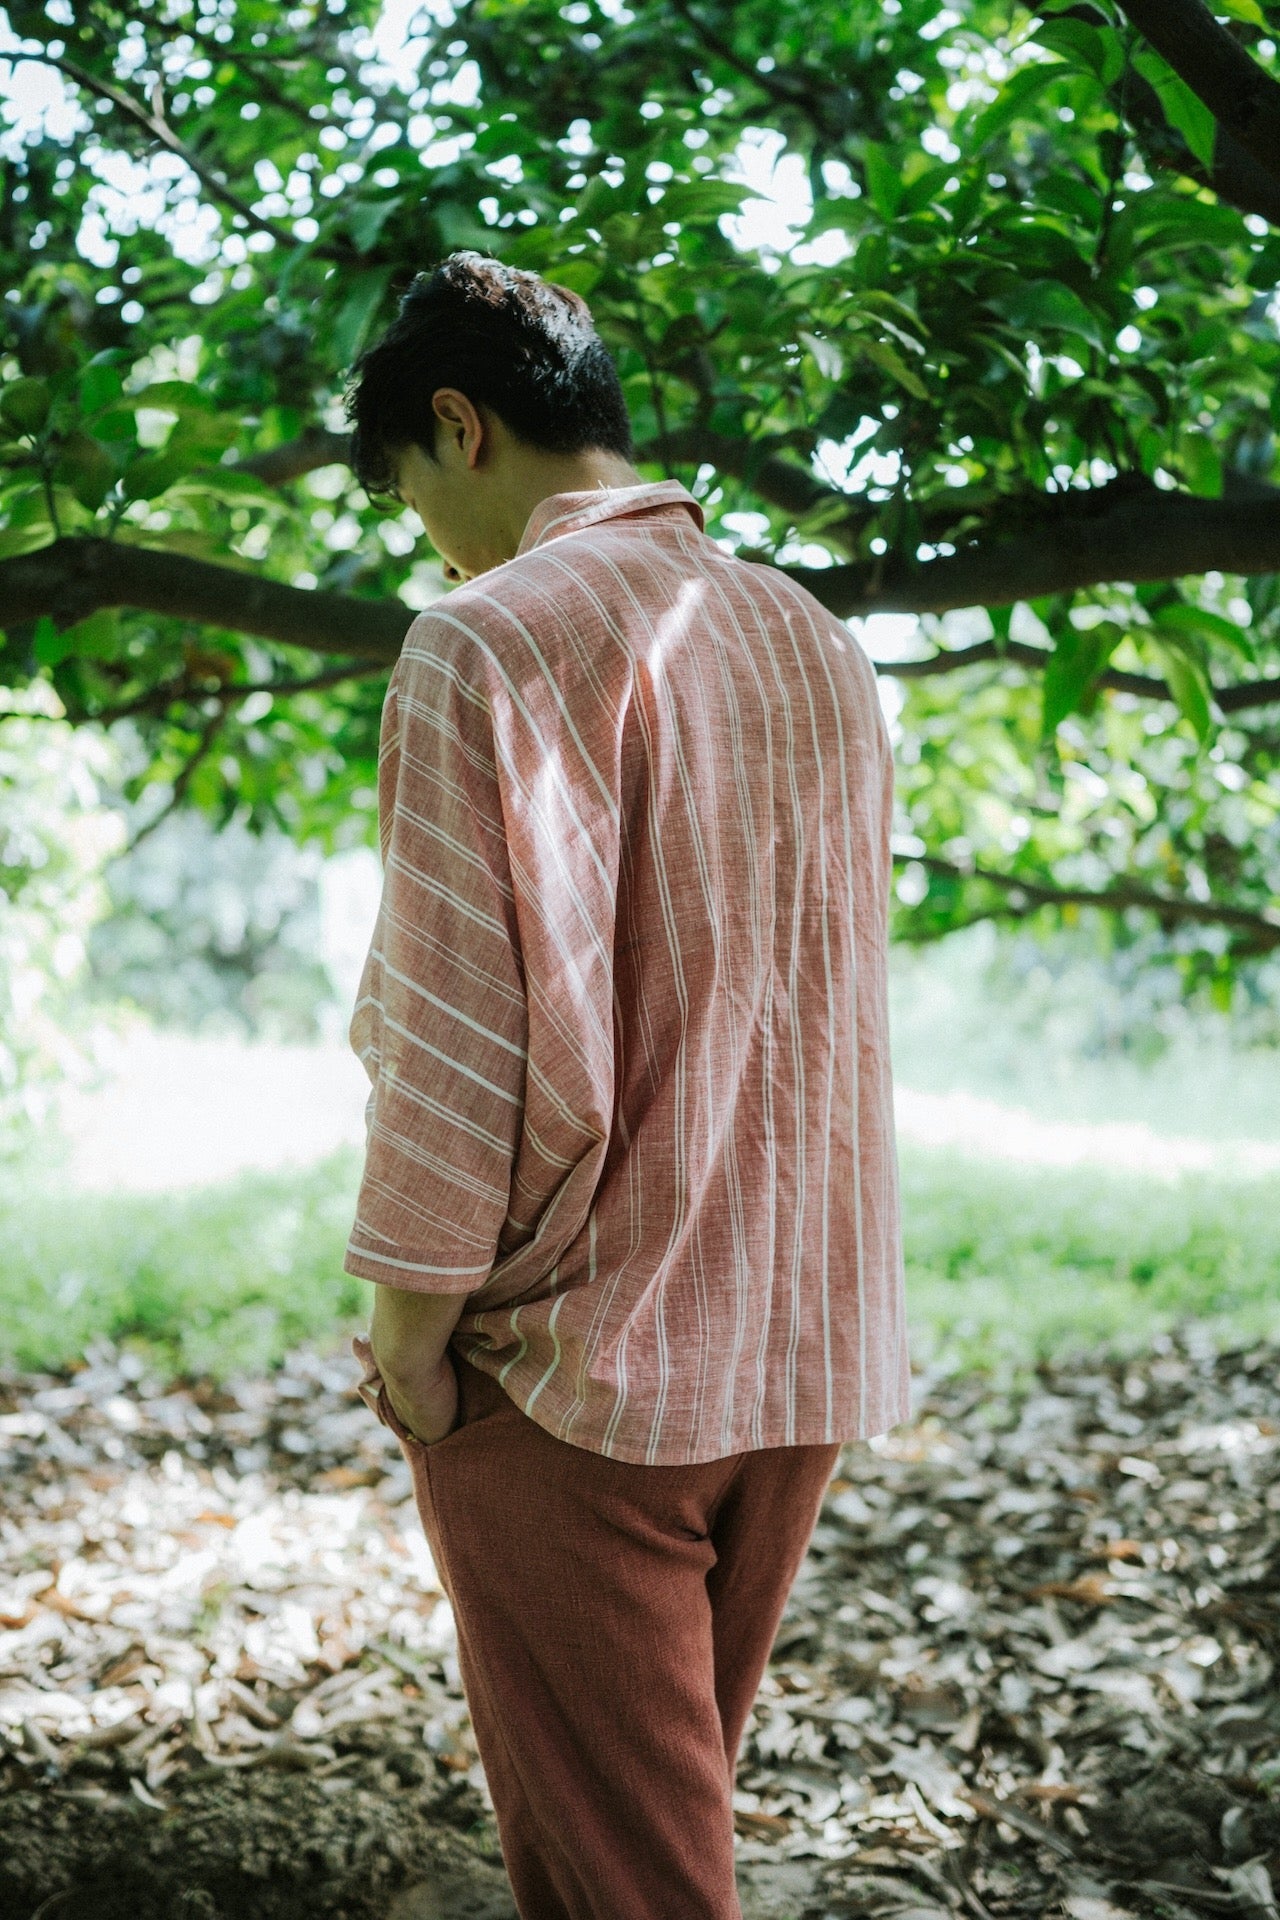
0, 0, 1280, 998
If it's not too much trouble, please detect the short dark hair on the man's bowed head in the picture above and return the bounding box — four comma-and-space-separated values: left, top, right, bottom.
347, 252, 633, 493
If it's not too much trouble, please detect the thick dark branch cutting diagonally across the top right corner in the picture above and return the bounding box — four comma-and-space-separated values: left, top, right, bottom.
1119, 0, 1280, 179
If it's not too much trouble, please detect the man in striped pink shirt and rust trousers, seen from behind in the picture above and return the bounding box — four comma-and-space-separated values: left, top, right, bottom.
345, 253, 908, 1920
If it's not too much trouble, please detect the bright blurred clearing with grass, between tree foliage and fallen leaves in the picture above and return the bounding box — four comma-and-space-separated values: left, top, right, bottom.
0, 624, 1280, 1397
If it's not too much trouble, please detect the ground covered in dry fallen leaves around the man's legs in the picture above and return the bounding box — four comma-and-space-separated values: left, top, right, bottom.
0, 1332, 1280, 1920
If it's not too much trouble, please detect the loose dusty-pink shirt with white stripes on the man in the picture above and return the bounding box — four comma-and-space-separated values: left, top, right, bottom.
345, 480, 908, 1465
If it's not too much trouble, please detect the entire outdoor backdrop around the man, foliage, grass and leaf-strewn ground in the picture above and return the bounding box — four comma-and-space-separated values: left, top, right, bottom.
0, 0, 1280, 1920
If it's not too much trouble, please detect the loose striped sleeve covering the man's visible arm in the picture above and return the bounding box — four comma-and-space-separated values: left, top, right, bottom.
344, 622, 528, 1294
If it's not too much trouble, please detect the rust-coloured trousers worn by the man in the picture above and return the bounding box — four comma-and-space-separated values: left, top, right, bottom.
380, 1361, 841, 1920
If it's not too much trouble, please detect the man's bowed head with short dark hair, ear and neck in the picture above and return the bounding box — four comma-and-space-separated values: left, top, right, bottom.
347, 253, 639, 580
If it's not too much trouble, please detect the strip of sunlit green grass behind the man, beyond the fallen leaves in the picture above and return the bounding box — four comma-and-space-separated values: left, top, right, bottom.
0, 1150, 1280, 1377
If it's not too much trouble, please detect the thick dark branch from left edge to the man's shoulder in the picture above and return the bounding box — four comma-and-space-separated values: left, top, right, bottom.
0, 538, 413, 662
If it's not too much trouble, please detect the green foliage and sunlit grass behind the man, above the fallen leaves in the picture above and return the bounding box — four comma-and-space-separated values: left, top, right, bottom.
0, 0, 1280, 1373
